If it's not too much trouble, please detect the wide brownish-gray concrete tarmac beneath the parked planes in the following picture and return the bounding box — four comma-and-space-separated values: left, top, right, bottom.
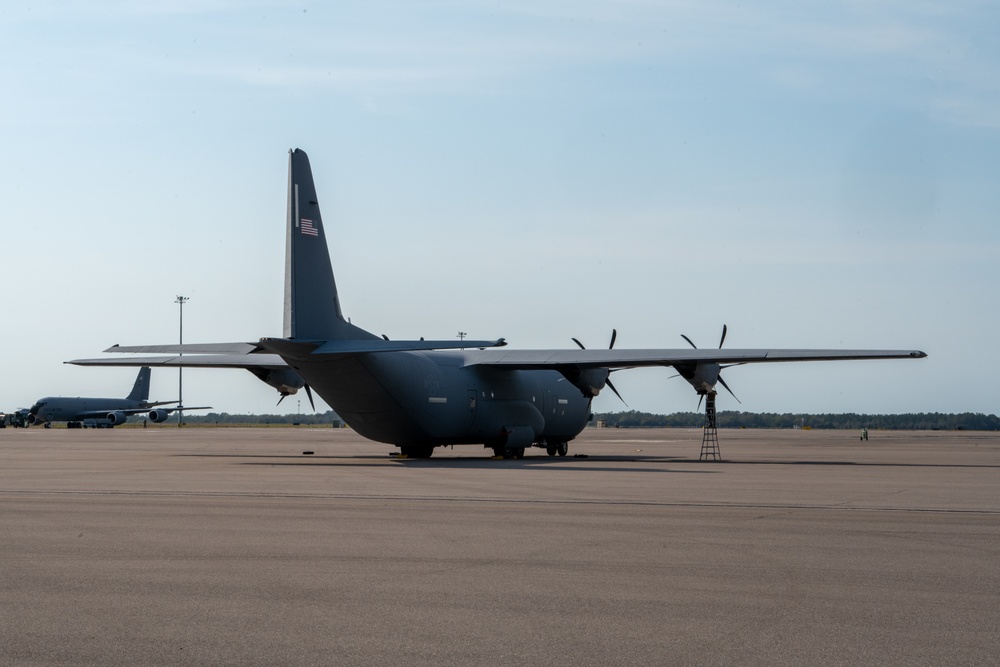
0, 427, 1000, 666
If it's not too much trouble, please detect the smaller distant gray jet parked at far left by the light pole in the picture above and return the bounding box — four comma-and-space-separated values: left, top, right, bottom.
27, 366, 208, 428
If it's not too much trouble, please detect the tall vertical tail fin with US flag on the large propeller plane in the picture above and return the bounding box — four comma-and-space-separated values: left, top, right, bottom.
284, 148, 377, 340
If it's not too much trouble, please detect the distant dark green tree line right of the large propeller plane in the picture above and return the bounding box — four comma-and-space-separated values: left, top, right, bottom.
594, 410, 1000, 431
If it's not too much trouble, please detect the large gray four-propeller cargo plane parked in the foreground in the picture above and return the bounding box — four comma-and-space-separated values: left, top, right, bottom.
67, 149, 927, 458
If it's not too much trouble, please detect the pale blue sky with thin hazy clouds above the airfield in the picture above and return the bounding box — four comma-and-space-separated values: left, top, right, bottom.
0, 0, 1000, 413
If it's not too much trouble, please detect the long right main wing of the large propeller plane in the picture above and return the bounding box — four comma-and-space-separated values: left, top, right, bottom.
465, 348, 927, 370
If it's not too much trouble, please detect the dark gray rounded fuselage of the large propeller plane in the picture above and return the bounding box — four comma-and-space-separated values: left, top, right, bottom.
291, 351, 590, 449
